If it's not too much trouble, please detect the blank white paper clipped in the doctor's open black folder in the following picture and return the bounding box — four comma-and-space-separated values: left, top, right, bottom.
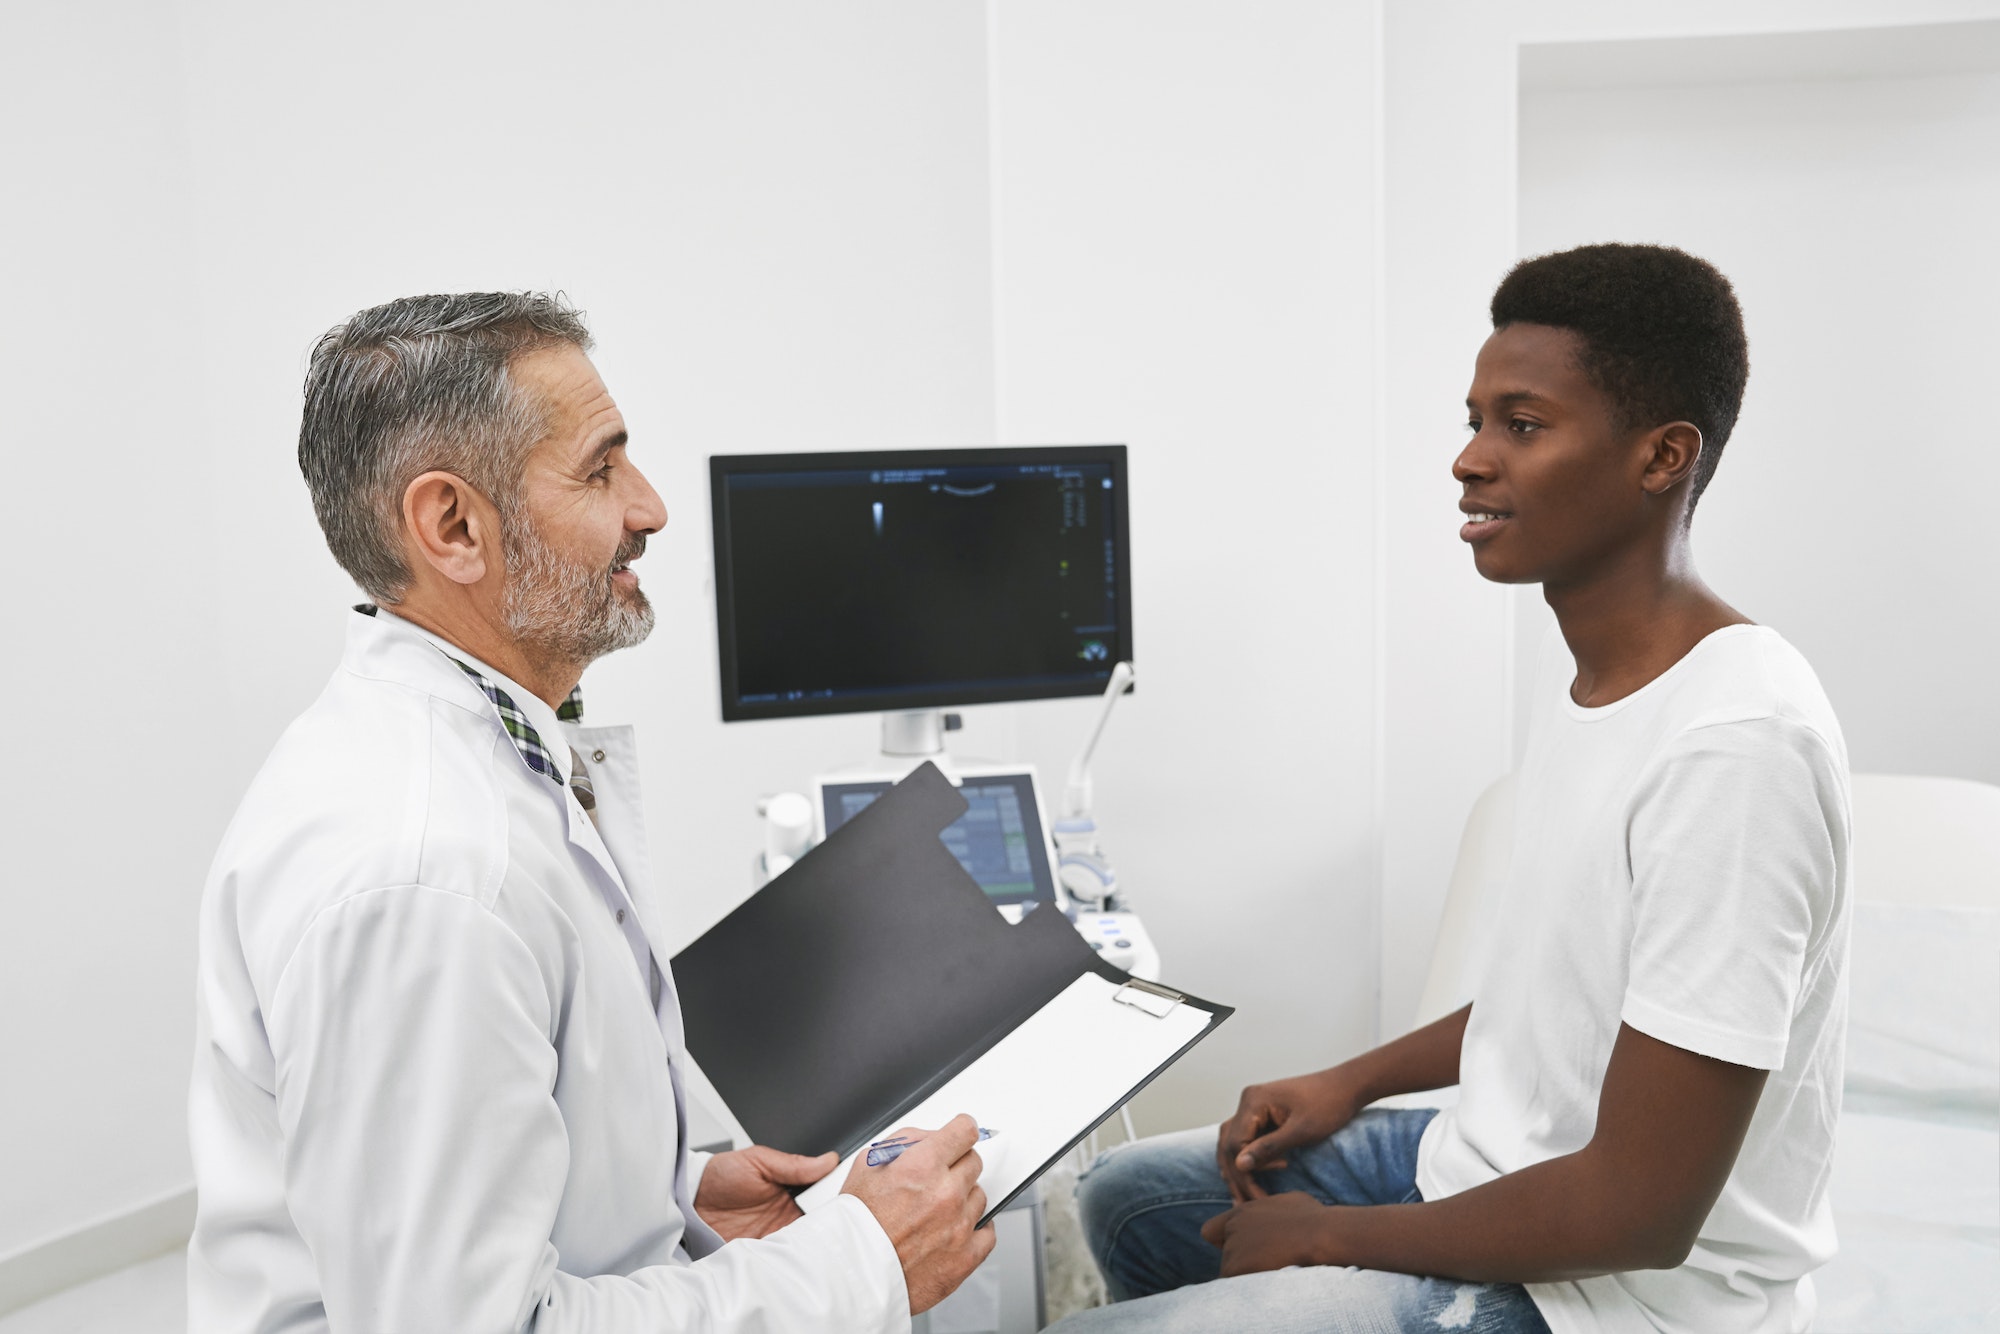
798, 972, 1216, 1212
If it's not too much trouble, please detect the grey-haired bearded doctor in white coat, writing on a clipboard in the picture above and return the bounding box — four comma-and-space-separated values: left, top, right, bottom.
188, 294, 992, 1334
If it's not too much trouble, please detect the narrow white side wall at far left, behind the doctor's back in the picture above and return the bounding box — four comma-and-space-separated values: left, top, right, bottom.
0, 6, 223, 1254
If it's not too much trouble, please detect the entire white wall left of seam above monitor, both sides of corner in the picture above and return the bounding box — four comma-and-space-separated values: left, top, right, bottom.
0, 0, 992, 1254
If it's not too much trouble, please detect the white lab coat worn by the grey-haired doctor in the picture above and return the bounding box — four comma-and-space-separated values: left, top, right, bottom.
188, 614, 910, 1334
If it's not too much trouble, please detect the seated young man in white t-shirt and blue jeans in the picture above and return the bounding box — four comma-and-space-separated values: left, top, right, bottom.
1064, 246, 1848, 1334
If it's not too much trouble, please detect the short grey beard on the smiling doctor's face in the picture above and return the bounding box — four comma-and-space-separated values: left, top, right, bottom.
500, 514, 652, 666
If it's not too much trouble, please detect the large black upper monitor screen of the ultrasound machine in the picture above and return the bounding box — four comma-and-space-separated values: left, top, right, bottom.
708, 444, 1132, 722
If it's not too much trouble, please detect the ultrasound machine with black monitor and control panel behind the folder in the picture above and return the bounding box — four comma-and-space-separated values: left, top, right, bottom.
708, 444, 1160, 978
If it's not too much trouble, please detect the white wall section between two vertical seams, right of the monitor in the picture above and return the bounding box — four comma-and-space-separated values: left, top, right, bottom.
992, 0, 1376, 1130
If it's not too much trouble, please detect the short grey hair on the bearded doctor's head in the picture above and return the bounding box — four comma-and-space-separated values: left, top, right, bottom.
298, 292, 590, 604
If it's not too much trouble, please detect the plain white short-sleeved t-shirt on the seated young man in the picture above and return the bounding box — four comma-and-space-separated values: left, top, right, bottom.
1416, 626, 1848, 1334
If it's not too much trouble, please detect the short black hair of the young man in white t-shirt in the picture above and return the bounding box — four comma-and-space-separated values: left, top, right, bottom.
1492, 244, 1750, 514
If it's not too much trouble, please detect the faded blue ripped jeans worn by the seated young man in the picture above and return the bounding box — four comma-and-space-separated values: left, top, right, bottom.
1054, 1108, 1548, 1334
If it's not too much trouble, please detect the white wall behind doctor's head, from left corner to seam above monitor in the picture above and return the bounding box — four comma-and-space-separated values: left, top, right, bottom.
174, 0, 1008, 938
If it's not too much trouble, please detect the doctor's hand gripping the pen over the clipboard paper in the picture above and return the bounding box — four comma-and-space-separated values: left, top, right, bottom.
844, 1116, 994, 1316
